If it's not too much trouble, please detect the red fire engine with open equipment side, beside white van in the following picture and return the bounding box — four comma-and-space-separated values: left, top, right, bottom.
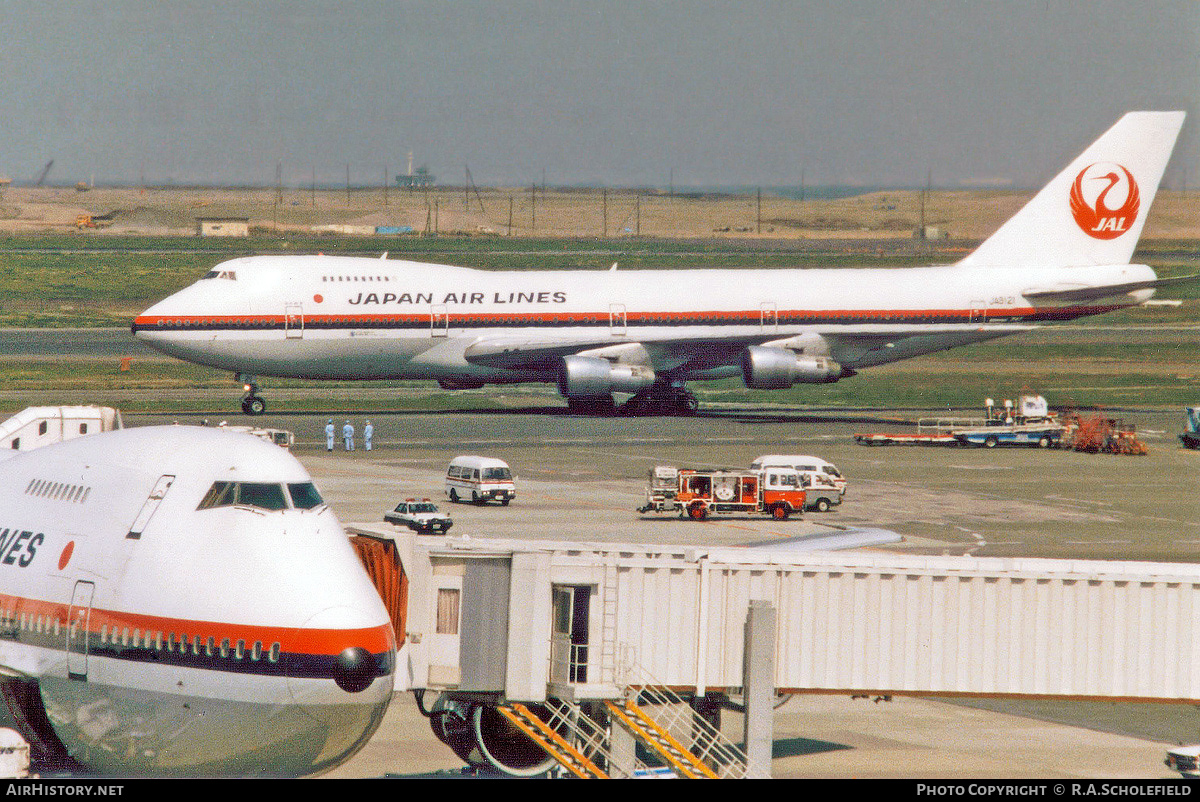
637, 465, 805, 521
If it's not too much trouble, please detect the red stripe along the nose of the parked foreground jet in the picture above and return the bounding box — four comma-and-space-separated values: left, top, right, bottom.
0, 594, 396, 656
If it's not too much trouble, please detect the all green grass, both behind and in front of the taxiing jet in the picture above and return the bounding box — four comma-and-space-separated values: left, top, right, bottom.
0, 234, 1200, 411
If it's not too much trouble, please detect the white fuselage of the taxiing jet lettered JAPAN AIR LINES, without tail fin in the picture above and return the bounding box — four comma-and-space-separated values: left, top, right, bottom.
133, 256, 1154, 382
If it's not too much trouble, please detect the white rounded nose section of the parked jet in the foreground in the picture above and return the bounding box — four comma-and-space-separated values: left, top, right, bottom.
0, 426, 396, 777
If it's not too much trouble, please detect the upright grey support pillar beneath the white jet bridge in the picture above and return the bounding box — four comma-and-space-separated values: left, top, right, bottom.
742, 600, 775, 778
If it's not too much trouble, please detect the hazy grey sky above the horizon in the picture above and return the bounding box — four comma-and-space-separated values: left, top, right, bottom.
0, 0, 1200, 187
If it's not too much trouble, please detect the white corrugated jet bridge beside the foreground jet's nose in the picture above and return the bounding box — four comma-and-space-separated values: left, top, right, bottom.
352, 526, 1200, 777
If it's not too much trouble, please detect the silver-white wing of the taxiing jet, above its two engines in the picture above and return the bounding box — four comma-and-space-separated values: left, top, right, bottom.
463, 323, 1037, 373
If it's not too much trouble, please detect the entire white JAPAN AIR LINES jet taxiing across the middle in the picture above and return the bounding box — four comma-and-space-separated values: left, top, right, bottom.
132, 112, 1184, 414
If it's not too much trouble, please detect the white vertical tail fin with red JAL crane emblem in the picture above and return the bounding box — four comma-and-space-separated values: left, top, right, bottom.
959, 112, 1184, 267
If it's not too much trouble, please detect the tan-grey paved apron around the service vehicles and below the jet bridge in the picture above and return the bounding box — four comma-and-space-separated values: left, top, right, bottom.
127, 407, 1200, 777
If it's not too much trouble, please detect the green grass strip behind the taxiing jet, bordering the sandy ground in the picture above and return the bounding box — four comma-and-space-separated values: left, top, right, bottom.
7, 234, 1200, 328
